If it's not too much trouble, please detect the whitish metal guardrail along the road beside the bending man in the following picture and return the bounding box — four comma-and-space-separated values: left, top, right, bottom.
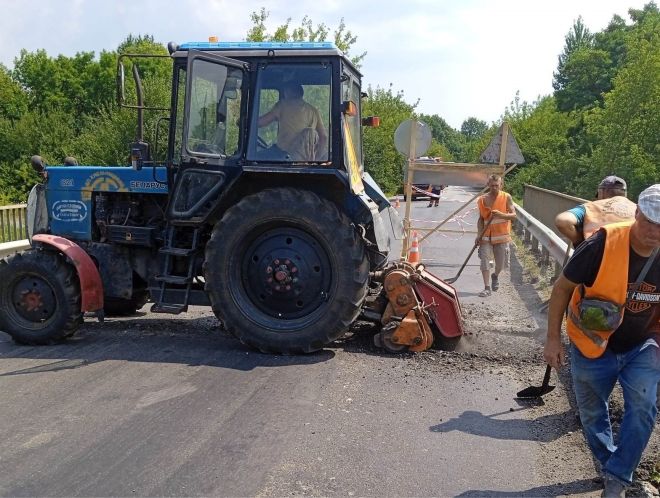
514, 204, 573, 276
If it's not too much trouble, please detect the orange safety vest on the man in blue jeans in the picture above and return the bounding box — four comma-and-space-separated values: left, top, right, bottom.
566, 221, 633, 358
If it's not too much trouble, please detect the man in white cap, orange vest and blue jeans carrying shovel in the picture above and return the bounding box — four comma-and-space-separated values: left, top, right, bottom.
544, 184, 660, 496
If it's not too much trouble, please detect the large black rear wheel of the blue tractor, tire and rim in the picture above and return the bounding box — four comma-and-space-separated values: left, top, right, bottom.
204, 188, 369, 354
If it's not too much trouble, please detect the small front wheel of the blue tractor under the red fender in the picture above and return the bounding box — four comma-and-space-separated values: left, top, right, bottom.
0, 250, 83, 344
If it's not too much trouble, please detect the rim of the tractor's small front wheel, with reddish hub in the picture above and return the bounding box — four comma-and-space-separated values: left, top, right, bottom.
12, 275, 57, 322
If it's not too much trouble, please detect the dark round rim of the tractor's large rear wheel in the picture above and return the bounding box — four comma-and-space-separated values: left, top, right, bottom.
241, 227, 332, 320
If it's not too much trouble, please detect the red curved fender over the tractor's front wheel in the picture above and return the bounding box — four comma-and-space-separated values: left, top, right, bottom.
32, 233, 103, 312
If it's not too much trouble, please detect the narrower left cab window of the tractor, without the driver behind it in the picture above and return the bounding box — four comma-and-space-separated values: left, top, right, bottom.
186, 59, 243, 158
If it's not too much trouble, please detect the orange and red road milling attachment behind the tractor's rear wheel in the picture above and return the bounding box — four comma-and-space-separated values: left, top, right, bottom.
368, 262, 463, 353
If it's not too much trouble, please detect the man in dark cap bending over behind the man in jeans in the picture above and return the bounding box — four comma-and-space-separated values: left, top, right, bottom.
555, 176, 637, 247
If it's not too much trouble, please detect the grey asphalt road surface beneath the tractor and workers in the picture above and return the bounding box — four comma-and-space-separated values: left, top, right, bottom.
0, 189, 599, 496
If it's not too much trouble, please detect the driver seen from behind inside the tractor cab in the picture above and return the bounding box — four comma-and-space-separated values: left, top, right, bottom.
258, 82, 328, 161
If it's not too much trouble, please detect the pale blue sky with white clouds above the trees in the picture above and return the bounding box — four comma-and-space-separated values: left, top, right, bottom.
0, 0, 649, 129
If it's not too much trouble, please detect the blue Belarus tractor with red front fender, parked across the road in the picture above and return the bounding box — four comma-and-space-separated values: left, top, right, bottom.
0, 42, 398, 353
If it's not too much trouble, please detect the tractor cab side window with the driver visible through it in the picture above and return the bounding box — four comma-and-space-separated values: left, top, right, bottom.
247, 63, 332, 163
